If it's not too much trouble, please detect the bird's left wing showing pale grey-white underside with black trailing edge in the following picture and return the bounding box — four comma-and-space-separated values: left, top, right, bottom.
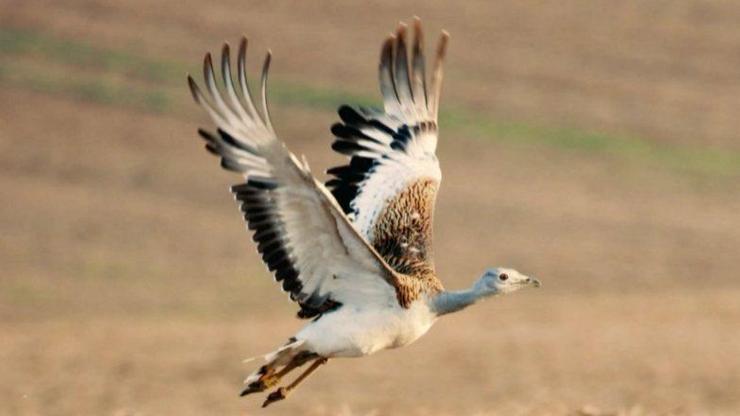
188, 39, 398, 318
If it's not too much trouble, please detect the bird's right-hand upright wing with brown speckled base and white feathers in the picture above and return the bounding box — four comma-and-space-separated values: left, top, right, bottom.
326, 18, 448, 276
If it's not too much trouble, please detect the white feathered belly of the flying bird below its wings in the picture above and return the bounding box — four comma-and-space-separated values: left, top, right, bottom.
297, 301, 435, 357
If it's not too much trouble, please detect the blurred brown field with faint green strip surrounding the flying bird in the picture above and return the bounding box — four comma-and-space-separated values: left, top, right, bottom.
0, 0, 740, 415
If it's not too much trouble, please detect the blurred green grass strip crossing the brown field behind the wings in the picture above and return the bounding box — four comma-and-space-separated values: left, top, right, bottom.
0, 28, 740, 177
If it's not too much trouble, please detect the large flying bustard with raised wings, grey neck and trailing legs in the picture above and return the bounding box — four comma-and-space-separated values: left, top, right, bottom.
188, 17, 540, 407
